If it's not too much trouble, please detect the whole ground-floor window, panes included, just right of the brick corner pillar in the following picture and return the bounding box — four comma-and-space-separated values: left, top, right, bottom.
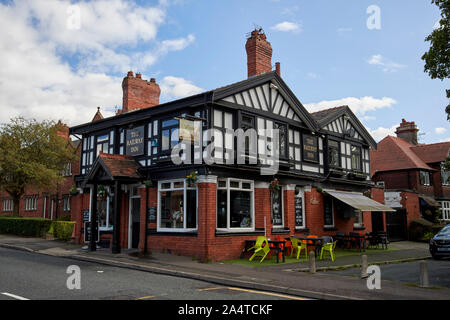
217, 178, 254, 230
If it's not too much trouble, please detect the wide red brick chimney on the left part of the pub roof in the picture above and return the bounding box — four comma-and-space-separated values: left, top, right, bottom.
117, 71, 161, 113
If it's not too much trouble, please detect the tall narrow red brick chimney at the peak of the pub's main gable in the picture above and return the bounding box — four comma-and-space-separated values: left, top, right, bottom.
245, 28, 272, 78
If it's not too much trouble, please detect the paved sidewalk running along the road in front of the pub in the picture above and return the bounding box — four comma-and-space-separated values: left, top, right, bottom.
0, 235, 450, 300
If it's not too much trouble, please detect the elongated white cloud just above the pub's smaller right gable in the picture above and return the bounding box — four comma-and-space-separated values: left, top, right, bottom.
305, 97, 397, 115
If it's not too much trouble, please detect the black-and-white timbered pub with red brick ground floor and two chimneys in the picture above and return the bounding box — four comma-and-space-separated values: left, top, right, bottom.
70, 29, 390, 261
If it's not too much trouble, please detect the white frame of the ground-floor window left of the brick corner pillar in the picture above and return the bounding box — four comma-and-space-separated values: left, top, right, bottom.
156, 179, 198, 232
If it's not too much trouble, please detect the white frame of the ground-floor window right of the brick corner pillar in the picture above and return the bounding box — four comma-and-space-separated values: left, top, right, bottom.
216, 178, 255, 232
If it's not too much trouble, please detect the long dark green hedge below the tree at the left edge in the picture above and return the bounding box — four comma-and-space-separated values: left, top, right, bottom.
0, 217, 52, 237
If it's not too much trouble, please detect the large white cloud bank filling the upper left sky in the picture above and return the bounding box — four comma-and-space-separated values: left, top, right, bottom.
0, 0, 199, 125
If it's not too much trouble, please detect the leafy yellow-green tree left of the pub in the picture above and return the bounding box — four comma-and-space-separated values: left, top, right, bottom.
0, 117, 75, 216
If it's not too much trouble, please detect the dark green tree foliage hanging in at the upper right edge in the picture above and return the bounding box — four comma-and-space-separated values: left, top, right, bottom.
422, 0, 450, 121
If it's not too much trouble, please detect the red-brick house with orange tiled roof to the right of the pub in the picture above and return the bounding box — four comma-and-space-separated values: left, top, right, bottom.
370, 119, 450, 239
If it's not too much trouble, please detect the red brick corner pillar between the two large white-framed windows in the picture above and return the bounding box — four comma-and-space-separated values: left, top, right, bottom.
197, 176, 217, 260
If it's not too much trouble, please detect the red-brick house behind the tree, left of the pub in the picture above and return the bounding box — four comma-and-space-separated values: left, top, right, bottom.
0, 122, 80, 220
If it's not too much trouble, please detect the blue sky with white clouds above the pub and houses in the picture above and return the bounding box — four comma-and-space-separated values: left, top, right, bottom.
0, 0, 450, 143
